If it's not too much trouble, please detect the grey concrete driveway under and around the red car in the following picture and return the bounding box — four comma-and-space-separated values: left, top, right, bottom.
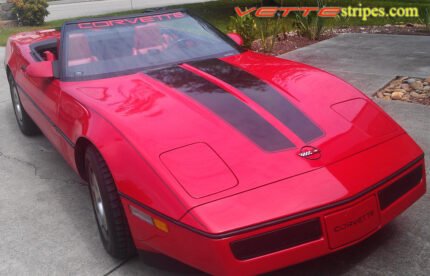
0, 34, 430, 275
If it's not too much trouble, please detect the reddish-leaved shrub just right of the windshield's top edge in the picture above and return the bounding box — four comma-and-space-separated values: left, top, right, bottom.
228, 9, 258, 48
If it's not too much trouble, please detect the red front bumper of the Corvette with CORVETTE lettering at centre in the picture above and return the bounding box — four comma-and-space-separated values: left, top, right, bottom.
122, 158, 426, 275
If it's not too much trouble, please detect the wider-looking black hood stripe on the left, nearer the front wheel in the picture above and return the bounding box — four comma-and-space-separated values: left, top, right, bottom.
146, 67, 295, 151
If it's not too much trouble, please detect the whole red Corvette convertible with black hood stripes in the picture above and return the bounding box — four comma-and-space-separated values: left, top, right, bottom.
5, 10, 426, 275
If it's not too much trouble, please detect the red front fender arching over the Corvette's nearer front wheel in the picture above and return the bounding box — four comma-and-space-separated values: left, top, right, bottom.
59, 89, 186, 219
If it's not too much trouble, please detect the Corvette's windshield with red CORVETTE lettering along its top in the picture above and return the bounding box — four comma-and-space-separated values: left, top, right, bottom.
62, 12, 238, 80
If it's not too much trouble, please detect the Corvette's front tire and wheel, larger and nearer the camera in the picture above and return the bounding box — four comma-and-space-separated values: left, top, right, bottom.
85, 146, 136, 259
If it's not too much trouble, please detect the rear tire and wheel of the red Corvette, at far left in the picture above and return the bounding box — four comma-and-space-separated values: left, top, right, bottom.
8, 74, 40, 136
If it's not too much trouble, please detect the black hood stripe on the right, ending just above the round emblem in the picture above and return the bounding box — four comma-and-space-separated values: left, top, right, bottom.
190, 59, 323, 143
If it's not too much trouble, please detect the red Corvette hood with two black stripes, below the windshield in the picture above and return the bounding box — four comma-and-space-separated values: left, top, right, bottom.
63, 52, 404, 216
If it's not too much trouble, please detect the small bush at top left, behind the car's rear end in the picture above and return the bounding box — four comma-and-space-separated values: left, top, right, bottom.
13, 0, 49, 26
